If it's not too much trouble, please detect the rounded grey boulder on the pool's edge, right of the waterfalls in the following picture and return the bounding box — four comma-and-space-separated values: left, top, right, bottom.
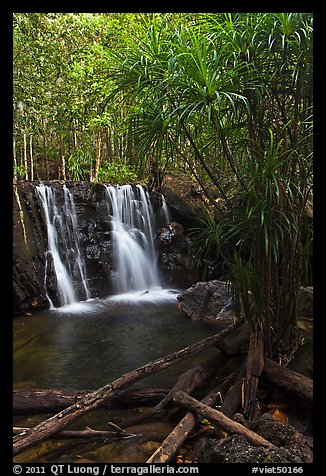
177, 279, 235, 321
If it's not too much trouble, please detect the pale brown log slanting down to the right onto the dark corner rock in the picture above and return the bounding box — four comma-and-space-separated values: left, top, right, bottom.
173, 391, 275, 449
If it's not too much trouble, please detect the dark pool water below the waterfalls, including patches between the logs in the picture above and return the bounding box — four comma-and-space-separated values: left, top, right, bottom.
13, 291, 217, 463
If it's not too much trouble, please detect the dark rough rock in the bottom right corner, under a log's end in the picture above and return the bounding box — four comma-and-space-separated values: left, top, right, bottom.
199, 413, 313, 463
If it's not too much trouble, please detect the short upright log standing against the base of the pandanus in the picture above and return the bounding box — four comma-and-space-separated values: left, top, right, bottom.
242, 331, 264, 420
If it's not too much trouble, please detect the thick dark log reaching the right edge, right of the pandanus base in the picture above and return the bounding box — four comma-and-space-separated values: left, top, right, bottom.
262, 359, 313, 405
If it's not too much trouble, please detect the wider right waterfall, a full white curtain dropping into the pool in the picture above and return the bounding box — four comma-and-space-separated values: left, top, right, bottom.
105, 185, 166, 294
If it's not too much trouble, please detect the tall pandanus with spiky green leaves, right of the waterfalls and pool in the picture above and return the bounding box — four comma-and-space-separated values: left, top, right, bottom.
110, 13, 312, 359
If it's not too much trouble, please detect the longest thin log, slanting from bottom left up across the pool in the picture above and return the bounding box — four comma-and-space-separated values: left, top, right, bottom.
13, 323, 239, 455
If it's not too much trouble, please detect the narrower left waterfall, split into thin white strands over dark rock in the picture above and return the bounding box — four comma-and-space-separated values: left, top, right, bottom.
36, 184, 90, 308
